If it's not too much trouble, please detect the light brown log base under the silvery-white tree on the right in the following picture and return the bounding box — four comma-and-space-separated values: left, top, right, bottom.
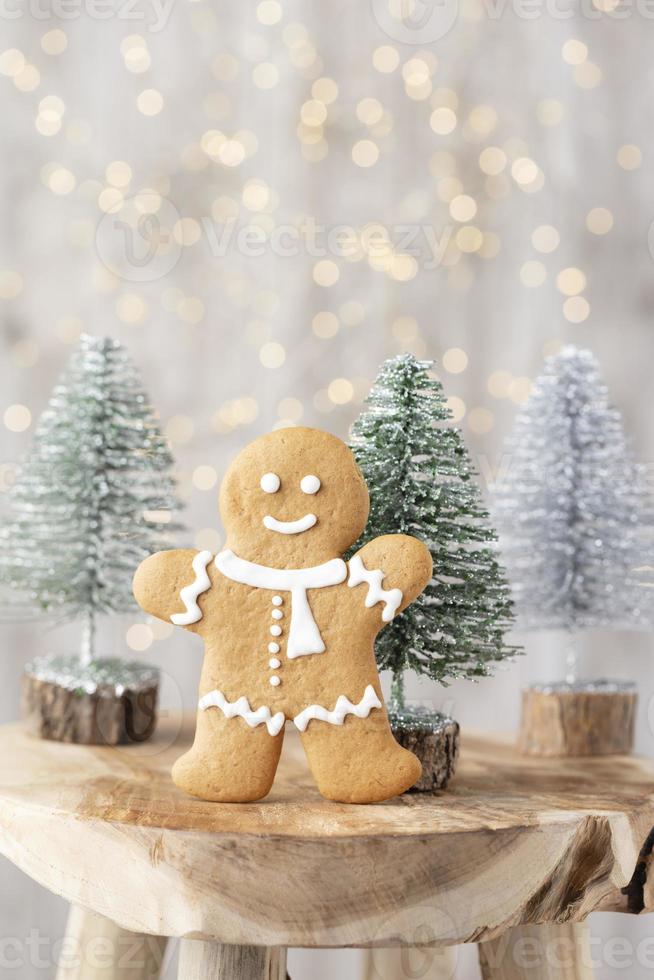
519, 681, 638, 756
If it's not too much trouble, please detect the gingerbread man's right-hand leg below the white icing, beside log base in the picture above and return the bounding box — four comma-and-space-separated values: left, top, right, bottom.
301, 709, 422, 803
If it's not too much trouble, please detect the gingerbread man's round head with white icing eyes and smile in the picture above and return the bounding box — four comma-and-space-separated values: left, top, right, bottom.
220, 428, 369, 568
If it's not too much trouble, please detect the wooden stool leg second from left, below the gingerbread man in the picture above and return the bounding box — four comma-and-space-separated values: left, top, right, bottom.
178, 939, 286, 980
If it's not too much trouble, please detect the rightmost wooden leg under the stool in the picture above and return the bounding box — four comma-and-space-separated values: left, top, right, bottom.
479, 922, 593, 980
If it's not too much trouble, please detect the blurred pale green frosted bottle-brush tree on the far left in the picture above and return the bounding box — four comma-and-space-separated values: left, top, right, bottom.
0, 336, 177, 677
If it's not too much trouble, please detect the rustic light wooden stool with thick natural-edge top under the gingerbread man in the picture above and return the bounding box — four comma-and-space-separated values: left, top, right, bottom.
0, 718, 654, 980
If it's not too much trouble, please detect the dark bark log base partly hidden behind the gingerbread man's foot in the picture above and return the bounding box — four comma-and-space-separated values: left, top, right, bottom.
389, 708, 459, 793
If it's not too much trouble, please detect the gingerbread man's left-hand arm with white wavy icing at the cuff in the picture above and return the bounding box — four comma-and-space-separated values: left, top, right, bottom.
132, 548, 213, 630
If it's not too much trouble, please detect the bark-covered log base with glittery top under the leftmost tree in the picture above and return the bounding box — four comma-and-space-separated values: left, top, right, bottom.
22, 657, 159, 745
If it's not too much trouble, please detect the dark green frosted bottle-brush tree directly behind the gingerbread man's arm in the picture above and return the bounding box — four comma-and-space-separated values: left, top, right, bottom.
351, 354, 518, 708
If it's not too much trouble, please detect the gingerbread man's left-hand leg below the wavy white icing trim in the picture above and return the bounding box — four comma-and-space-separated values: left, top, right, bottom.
173, 708, 284, 803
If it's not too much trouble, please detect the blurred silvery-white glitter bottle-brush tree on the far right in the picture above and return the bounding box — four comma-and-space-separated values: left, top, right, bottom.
493, 346, 654, 640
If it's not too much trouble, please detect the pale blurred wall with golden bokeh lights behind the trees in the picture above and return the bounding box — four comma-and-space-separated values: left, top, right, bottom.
0, 0, 654, 980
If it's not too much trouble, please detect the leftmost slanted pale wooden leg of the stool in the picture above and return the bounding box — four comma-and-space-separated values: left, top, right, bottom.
57, 906, 168, 980
